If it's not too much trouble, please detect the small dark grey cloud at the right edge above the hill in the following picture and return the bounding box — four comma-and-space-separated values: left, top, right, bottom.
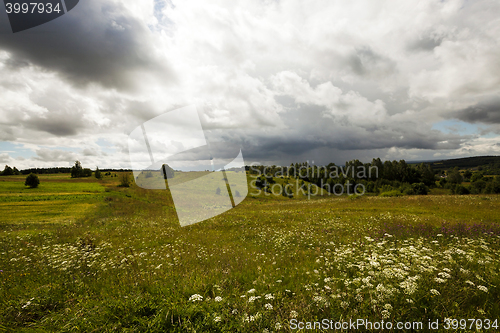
456, 96, 500, 124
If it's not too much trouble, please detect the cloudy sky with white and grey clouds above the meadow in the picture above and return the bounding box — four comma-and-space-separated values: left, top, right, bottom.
0, 0, 500, 169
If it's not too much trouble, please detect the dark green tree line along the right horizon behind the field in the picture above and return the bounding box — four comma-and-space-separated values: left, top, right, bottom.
246, 158, 500, 196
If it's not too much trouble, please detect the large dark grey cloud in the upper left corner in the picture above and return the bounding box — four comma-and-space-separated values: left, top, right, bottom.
0, 0, 173, 88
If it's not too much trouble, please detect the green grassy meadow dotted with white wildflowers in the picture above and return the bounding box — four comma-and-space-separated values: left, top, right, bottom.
0, 175, 500, 332
